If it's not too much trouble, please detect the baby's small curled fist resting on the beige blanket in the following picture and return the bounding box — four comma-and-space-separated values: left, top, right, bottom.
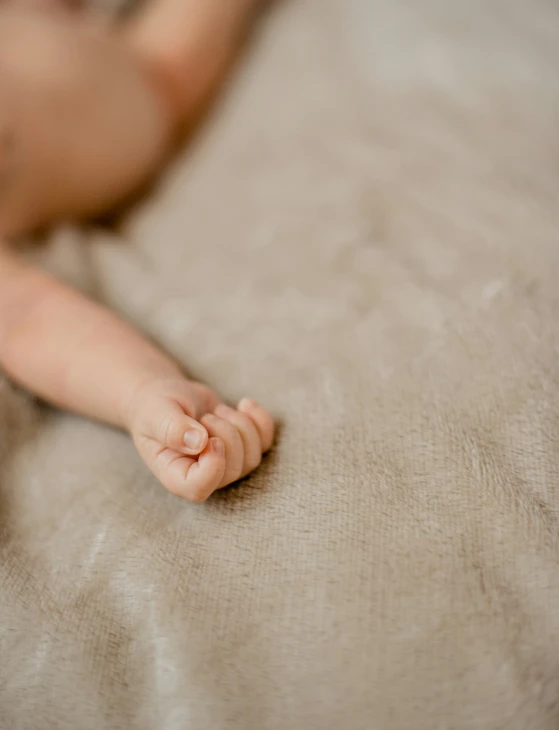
127, 376, 274, 502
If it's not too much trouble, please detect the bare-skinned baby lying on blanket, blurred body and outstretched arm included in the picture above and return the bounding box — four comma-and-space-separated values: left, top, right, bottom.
0, 0, 274, 502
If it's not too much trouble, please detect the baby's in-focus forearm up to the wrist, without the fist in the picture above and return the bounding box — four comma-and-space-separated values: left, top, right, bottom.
0, 255, 179, 427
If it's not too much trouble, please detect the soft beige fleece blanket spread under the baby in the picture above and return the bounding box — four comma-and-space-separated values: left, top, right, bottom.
0, 0, 559, 730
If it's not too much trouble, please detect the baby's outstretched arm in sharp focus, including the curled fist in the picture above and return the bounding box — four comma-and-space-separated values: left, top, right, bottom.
0, 248, 273, 502
